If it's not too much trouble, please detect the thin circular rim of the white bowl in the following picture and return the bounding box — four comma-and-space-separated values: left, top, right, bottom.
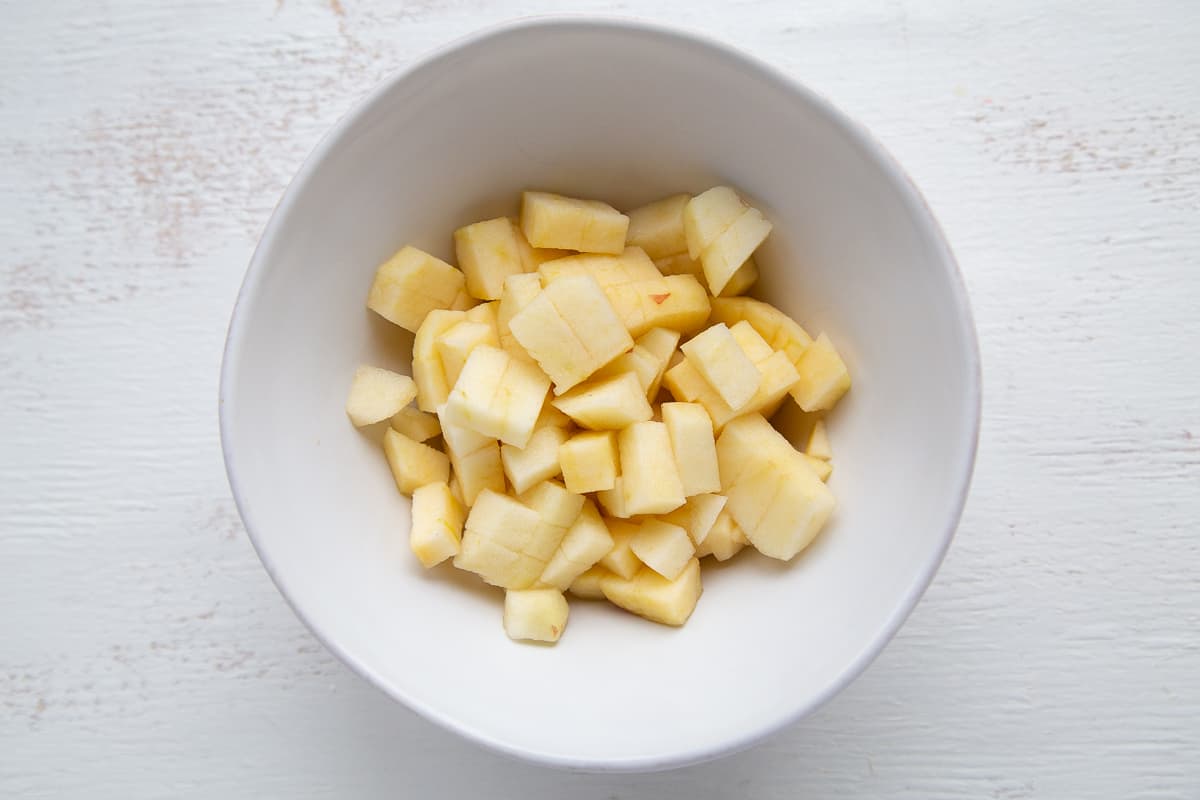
217, 14, 983, 772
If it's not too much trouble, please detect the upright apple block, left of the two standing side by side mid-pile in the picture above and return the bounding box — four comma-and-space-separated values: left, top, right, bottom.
617, 422, 685, 515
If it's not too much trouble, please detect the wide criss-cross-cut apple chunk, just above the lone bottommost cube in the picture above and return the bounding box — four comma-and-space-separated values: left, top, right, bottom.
454, 489, 546, 589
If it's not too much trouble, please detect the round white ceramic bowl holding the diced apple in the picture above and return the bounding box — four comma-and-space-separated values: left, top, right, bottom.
221, 14, 979, 770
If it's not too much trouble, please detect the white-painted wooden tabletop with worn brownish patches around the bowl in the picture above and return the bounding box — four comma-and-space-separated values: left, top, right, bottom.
0, 0, 1200, 800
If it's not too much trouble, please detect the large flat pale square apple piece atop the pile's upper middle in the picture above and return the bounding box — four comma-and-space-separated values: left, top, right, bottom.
509, 276, 634, 395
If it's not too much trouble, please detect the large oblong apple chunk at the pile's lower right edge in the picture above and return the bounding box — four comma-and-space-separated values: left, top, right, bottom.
716, 414, 834, 561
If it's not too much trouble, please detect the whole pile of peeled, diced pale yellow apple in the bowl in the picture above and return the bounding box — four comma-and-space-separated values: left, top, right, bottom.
347, 187, 850, 642
